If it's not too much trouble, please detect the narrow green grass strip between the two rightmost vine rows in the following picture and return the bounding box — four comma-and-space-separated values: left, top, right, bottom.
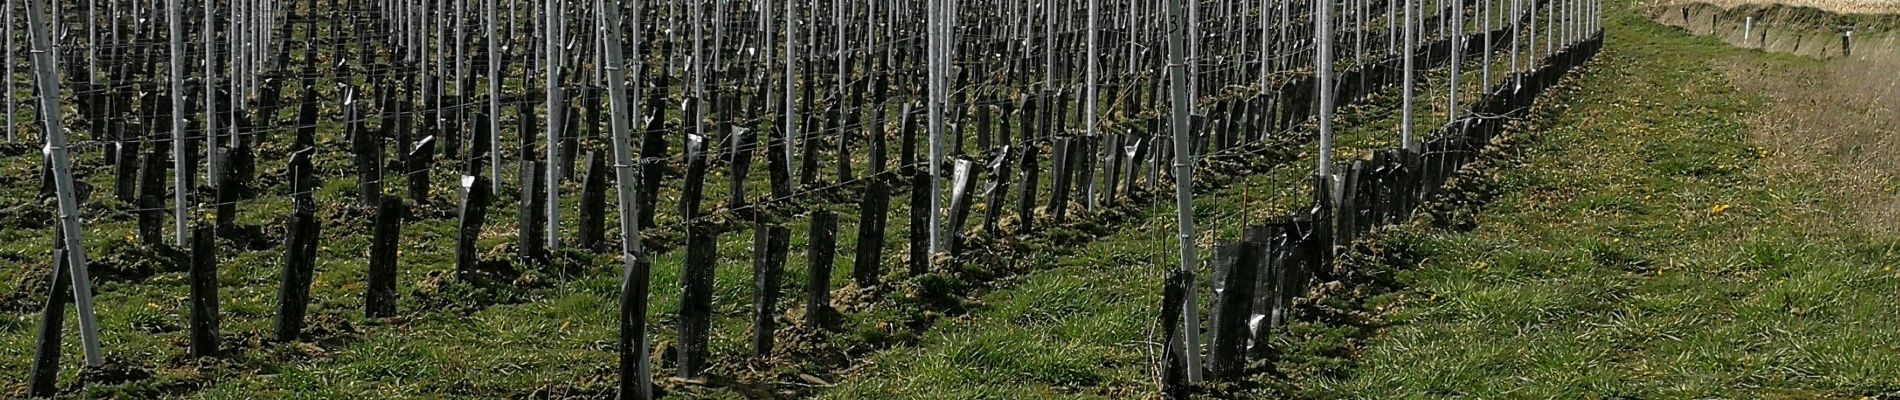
821, 21, 1558, 398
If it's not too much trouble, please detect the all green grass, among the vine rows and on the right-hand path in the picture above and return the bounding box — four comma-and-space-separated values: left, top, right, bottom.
11, 4, 1900, 398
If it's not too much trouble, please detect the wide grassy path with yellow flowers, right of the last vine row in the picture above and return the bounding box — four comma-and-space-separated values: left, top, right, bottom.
1300, 4, 1900, 398
